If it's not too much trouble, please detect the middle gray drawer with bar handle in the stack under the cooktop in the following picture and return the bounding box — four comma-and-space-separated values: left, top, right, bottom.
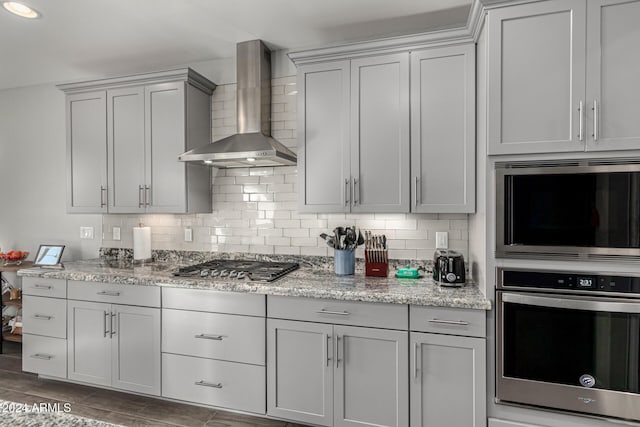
162, 309, 265, 366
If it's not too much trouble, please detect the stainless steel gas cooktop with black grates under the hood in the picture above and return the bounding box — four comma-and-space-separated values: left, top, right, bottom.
174, 259, 300, 282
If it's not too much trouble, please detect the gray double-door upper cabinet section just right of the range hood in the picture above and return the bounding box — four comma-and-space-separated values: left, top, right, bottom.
298, 53, 409, 212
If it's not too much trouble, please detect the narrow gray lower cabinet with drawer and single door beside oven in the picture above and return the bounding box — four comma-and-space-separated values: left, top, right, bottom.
409, 305, 487, 427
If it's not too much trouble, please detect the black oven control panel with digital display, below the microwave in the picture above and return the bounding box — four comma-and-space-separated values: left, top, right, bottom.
498, 269, 640, 297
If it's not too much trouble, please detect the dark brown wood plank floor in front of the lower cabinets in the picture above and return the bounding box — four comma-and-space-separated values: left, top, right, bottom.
0, 342, 303, 427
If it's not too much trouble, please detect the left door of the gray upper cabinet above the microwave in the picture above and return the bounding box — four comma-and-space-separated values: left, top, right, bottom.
487, 0, 586, 154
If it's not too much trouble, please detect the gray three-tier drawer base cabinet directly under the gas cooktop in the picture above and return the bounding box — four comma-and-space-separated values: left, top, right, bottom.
162, 287, 266, 415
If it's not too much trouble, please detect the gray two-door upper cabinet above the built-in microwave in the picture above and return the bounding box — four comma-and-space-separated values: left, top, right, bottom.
487, 0, 640, 154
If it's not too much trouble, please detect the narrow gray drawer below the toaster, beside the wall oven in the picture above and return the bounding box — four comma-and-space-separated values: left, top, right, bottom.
410, 305, 487, 338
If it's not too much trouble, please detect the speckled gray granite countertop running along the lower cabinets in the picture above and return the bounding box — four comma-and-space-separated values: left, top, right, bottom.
18, 259, 491, 310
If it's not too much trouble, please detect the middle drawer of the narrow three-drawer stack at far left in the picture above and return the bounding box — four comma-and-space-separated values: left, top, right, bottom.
22, 295, 67, 339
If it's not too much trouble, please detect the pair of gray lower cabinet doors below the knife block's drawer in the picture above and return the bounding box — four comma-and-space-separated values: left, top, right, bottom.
267, 319, 408, 426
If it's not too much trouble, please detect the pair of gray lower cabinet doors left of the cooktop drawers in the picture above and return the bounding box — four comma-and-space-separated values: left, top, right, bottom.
67, 300, 160, 395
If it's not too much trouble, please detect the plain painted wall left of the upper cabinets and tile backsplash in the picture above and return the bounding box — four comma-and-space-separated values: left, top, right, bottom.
0, 84, 102, 260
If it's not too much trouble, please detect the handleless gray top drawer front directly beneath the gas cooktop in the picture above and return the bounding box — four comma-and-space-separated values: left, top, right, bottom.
162, 288, 265, 316
